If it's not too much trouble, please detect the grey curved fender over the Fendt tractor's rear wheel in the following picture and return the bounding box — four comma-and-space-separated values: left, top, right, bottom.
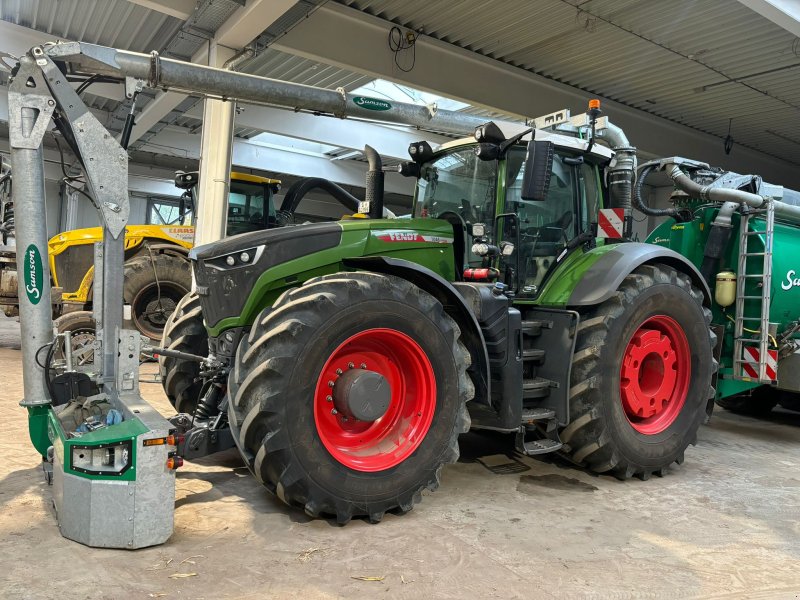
567, 242, 711, 307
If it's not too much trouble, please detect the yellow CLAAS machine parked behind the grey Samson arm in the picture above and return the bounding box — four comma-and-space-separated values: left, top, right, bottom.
0, 169, 280, 344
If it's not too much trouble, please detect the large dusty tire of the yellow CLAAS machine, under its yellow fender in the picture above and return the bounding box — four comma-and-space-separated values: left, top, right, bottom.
122, 254, 192, 341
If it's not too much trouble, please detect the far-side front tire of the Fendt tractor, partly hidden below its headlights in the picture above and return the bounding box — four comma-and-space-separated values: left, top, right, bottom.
158, 292, 208, 414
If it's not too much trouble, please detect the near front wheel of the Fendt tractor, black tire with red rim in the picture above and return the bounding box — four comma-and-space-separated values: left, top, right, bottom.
228, 273, 475, 523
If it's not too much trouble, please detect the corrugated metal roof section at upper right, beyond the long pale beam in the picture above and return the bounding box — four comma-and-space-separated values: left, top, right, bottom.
337, 0, 800, 165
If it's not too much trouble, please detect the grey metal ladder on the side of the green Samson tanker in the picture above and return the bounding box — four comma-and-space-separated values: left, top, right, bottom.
733, 201, 776, 384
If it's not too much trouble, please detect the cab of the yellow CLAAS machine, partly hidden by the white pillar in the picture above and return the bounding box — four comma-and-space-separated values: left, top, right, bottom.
175, 171, 281, 236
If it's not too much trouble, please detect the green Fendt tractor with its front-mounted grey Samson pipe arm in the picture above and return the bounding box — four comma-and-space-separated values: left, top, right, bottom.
9, 43, 717, 548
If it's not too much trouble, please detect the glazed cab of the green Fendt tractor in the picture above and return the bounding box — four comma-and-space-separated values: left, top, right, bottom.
413, 141, 602, 299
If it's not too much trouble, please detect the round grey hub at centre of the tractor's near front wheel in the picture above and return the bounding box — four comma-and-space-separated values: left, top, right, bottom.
333, 369, 392, 421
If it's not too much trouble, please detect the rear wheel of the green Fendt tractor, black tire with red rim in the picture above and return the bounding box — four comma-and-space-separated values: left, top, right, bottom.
561, 265, 717, 479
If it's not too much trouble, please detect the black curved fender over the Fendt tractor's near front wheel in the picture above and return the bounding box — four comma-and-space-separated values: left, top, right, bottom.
342, 256, 491, 404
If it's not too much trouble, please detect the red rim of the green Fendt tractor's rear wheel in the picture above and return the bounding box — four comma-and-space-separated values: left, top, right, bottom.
620, 315, 692, 435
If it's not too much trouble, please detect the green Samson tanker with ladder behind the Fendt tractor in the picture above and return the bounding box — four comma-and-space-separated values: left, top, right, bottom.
635, 157, 800, 415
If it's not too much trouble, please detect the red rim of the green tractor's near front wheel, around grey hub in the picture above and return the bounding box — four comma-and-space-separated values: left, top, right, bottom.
314, 329, 436, 472
